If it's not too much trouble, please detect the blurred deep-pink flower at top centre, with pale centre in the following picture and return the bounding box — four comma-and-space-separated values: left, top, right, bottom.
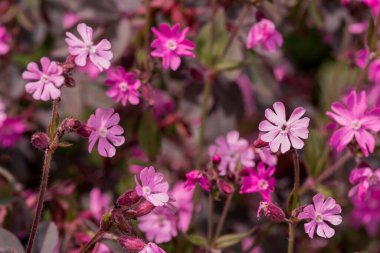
151, 24, 195, 70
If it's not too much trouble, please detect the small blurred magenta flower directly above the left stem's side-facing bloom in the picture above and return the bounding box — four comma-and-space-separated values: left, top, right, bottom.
105, 67, 141, 106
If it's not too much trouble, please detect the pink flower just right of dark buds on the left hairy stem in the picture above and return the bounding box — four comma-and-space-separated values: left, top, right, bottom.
87, 108, 125, 157
